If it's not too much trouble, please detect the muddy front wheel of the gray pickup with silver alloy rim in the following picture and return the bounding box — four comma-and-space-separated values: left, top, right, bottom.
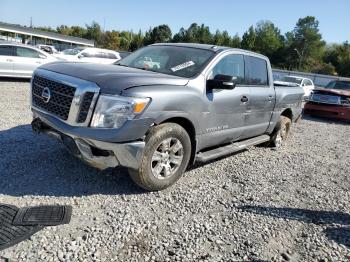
129, 123, 191, 191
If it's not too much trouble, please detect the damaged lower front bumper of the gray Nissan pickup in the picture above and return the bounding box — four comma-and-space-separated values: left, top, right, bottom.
32, 111, 145, 170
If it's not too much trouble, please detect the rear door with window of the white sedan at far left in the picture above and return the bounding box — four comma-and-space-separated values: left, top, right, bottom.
13, 46, 47, 77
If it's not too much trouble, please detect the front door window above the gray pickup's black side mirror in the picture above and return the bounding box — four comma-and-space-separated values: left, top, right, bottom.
209, 55, 244, 84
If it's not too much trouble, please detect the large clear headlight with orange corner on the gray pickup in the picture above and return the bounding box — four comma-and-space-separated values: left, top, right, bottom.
91, 95, 150, 128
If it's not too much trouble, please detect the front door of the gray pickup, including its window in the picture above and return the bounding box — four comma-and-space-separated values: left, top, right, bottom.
201, 54, 249, 147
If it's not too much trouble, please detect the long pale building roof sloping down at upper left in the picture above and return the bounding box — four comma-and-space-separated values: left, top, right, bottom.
0, 22, 94, 46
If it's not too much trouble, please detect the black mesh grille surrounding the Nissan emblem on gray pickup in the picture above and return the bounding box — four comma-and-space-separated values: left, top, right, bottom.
32, 76, 75, 120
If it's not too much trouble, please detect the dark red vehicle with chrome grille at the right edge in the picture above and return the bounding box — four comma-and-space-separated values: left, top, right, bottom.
304, 80, 350, 120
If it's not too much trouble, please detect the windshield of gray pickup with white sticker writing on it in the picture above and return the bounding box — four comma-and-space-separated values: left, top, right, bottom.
116, 46, 215, 78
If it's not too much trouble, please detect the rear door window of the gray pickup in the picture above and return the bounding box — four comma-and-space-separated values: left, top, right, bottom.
245, 56, 269, 86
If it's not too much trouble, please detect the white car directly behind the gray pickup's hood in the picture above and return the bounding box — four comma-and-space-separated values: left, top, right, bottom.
54, 47, 121, 64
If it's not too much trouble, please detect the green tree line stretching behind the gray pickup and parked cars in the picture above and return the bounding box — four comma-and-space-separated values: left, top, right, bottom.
37, 16, 350, 76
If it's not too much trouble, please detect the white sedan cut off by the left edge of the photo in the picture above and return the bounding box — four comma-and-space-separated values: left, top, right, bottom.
0, 43, 57, 78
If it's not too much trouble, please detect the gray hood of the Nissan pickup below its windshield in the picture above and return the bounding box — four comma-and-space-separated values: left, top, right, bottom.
40, 62, 188, 94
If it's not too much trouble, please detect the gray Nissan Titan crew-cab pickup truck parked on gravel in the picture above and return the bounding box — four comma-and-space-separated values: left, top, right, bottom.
31, 44, 303, 190
